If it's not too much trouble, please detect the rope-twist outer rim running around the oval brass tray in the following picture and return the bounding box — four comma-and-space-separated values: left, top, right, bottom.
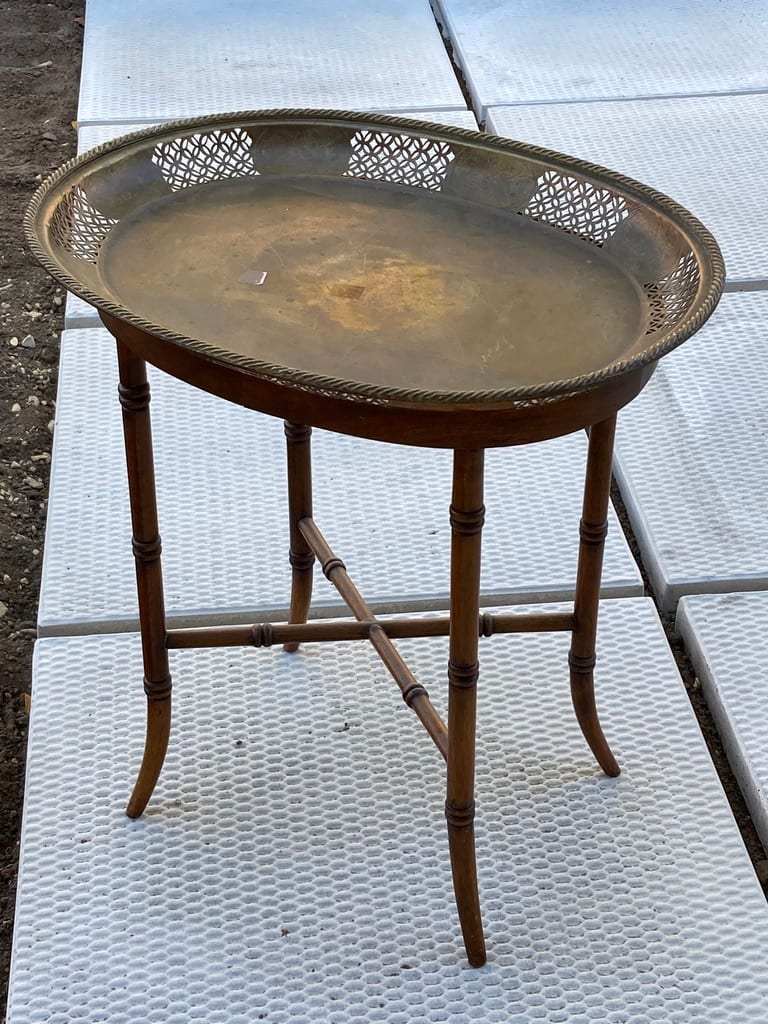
24, 108, 725, 406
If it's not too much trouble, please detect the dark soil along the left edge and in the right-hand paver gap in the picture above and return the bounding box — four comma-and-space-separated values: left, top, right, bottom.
0, 0, 768, 1022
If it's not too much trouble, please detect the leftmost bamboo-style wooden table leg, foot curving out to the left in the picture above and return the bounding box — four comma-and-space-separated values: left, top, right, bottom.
118, 342, 171, 818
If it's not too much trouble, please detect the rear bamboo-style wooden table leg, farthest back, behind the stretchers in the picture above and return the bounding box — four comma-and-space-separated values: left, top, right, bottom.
283, 422, 314, 651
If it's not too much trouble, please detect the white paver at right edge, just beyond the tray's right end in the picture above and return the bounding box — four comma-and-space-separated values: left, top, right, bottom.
615, 292, 768, 609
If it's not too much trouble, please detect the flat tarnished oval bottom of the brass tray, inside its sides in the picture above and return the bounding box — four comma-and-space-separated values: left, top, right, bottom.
99, 177, 645, 389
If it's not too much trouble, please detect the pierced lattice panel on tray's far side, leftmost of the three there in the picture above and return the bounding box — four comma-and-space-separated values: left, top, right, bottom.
153, 128, 259, 191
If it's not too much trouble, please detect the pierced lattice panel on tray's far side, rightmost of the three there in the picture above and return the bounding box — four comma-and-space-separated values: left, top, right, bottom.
524, 171, 629, 246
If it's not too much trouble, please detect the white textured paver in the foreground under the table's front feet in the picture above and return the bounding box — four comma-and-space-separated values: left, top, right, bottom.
8, 599, 768, 1024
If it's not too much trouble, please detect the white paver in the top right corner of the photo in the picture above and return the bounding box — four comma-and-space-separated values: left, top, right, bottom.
434, 0, 768, 119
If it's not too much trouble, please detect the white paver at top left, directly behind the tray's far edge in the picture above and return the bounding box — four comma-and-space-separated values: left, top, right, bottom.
78, 0, 466, 125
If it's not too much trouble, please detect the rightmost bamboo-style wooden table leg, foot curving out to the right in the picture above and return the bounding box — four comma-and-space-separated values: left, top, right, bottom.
568, 416, 621, 775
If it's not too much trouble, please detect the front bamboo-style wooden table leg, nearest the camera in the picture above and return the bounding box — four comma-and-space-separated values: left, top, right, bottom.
445, 450, 485, 967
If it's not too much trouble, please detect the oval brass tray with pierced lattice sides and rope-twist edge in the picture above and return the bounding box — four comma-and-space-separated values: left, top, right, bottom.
26, 111, 724, 402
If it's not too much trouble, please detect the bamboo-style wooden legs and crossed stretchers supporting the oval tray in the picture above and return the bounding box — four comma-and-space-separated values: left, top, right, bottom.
118, 341, 620, 967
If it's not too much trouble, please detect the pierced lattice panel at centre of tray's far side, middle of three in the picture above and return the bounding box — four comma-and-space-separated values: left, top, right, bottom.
345, 131, 455, 189
